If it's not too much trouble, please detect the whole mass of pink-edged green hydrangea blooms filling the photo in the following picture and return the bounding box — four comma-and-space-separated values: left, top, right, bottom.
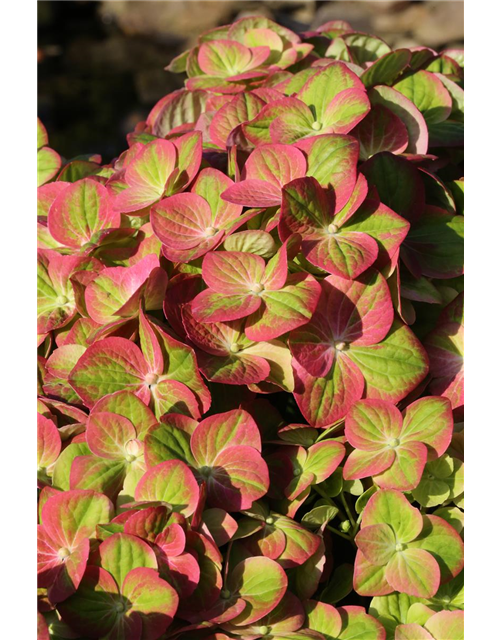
37, 17, 464, 640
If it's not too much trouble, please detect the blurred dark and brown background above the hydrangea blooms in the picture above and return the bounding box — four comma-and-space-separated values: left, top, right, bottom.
37, 0, 464, 162
